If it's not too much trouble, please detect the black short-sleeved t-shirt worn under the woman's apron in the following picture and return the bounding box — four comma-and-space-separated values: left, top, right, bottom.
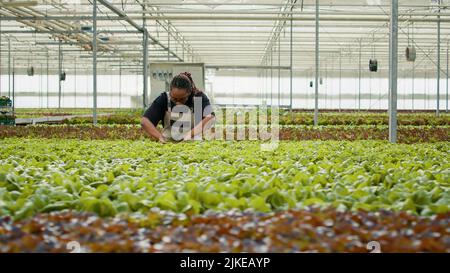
144, 92, 214, 126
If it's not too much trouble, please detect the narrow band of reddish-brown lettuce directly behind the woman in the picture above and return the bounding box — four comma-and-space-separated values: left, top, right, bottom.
0, 124, 450, 143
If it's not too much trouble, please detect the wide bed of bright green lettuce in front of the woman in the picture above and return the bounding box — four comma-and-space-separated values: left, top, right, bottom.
0, 138, 450, 219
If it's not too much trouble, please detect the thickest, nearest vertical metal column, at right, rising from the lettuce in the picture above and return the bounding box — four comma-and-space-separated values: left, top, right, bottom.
389, 0, 398, 143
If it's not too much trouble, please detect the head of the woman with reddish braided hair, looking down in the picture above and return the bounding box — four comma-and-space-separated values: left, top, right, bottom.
170, 72, 199, 104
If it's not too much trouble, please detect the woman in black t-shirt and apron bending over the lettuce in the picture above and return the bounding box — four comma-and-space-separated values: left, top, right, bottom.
141, 72, 214, 143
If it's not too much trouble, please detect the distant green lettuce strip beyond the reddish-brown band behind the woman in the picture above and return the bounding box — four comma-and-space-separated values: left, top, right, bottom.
16, 107, 450, 126
